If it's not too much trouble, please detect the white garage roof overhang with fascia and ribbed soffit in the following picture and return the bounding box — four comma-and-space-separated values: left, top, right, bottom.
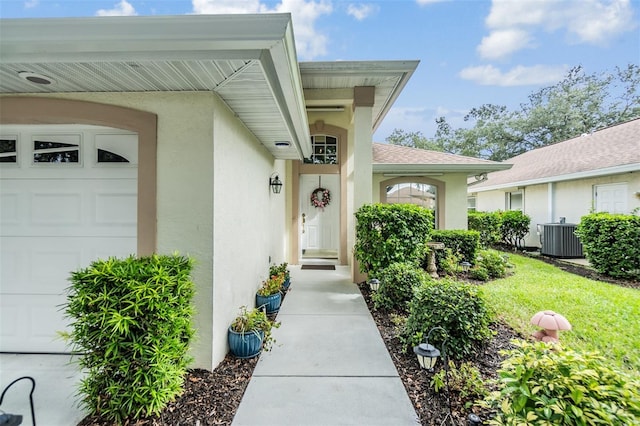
0, 14, 311, 159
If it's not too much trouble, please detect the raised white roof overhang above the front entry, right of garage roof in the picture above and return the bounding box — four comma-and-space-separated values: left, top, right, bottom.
300, 61, 420, 131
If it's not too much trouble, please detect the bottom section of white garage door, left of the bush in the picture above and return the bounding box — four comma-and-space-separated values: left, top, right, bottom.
0, 295, 69, 352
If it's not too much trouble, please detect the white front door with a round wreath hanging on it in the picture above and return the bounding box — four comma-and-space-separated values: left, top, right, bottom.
299, 174, 340, 257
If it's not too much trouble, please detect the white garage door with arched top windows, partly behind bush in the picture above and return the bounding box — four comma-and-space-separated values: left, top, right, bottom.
0, 126, 138, 353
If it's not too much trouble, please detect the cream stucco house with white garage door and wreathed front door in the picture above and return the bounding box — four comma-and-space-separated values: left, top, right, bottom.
0, 14, 510, 369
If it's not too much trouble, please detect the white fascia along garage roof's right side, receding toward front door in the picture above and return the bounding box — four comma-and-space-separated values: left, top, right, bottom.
261, 19, 311, 160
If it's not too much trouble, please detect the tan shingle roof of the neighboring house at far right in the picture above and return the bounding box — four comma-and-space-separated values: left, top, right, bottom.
473, 118, 640, 191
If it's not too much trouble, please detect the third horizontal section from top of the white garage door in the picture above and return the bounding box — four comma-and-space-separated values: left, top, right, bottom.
0, 237, 136, 295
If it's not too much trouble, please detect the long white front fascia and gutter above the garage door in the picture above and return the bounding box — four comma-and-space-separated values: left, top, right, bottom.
0, 14, 290, 62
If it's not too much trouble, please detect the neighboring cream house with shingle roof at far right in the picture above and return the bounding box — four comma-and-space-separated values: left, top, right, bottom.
468, 119, 640, 247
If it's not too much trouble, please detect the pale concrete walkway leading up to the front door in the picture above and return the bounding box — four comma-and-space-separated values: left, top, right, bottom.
233, 266, 419, 426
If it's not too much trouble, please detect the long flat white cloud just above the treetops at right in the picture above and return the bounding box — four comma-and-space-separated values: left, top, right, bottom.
459, 65, 568, 86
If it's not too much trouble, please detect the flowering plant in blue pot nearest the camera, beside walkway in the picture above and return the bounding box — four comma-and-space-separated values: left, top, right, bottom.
227, 306, 280, 358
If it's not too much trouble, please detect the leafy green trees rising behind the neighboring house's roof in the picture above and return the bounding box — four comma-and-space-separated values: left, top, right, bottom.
386, 64, 640, 161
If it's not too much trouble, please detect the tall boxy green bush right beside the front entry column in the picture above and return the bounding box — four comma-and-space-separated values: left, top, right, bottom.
354, 204, 433, 273
